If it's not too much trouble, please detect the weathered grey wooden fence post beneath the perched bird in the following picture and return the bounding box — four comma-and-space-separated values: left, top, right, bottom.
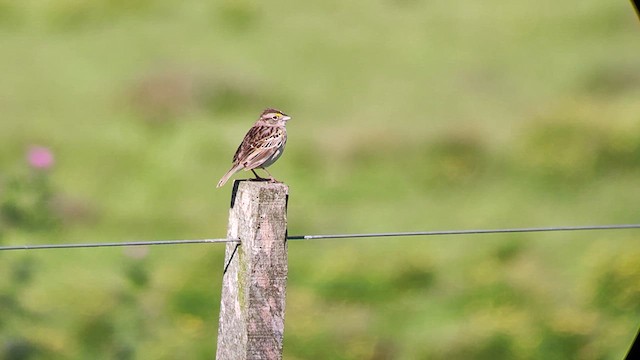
216, 180, 289, 360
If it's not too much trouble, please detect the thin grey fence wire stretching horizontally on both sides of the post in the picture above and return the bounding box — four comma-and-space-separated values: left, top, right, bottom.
0, 224, 640, 251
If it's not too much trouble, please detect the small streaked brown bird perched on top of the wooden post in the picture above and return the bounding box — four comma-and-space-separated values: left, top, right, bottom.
217, 109, 291, 187
